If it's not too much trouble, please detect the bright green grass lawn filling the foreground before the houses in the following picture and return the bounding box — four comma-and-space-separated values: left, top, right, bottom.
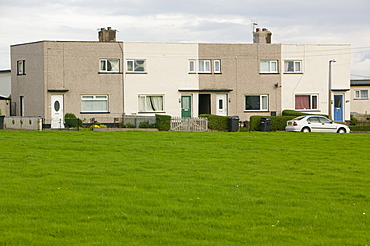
0, 130, 370, 246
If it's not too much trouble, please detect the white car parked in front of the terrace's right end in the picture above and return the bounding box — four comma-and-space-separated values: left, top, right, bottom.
285, 115, 351, 133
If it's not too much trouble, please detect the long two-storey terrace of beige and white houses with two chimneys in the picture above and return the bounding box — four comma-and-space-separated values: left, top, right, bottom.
11, 28, 350, 128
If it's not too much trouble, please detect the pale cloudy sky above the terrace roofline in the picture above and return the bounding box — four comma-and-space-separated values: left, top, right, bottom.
0, 0, 370, 79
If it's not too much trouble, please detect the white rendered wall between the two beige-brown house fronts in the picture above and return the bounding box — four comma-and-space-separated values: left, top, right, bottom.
123, 42, 199, 117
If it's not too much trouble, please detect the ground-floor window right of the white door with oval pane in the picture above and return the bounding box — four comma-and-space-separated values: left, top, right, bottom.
81, 95, 108, 113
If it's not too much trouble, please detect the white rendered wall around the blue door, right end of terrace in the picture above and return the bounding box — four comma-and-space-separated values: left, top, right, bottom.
280, 44, 351, 120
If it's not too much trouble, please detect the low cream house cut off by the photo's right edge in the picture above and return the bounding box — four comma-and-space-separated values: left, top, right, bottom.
351, 79, 370, 115
